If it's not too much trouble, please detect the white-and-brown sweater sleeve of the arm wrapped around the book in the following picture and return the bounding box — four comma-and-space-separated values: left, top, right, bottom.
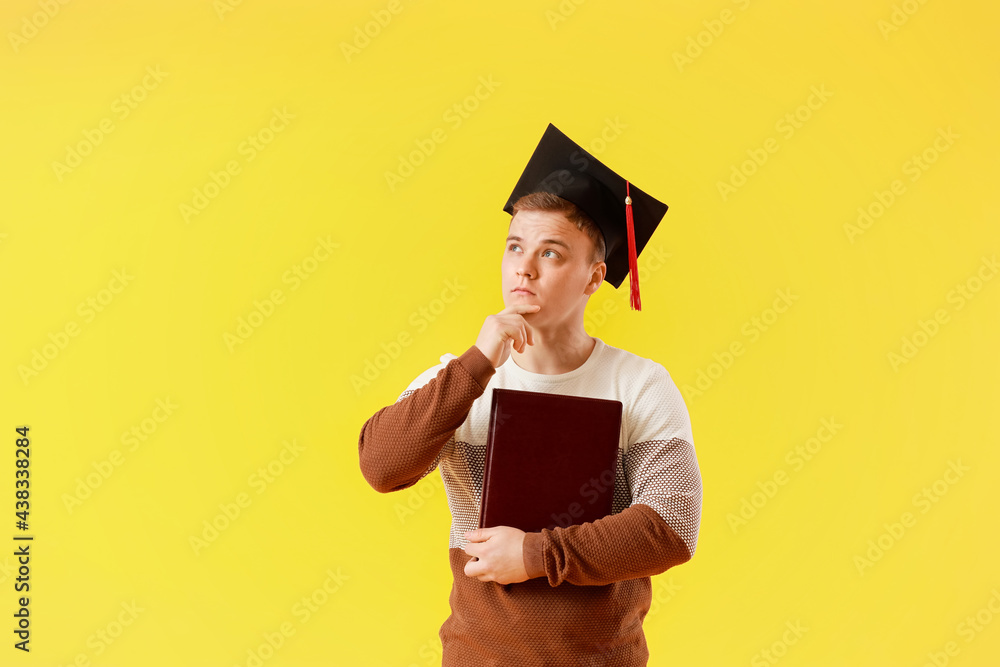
523, 366, 702, 586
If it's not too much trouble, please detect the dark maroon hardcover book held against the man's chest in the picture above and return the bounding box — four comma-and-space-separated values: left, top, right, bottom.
479, 389, 622, 532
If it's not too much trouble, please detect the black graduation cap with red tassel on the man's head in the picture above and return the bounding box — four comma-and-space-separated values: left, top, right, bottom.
503, 123, 667, 310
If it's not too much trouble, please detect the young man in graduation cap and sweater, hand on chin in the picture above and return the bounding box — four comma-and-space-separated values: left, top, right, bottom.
358, 125, 702, 667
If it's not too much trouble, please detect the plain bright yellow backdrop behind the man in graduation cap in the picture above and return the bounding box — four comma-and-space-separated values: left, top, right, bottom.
0, 0, 1000, 667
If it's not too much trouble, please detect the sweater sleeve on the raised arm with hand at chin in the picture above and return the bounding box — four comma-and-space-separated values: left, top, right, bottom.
358, 345, 496, 493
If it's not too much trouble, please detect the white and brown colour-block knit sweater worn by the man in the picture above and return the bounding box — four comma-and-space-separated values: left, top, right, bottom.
358, 338, 702, 667
